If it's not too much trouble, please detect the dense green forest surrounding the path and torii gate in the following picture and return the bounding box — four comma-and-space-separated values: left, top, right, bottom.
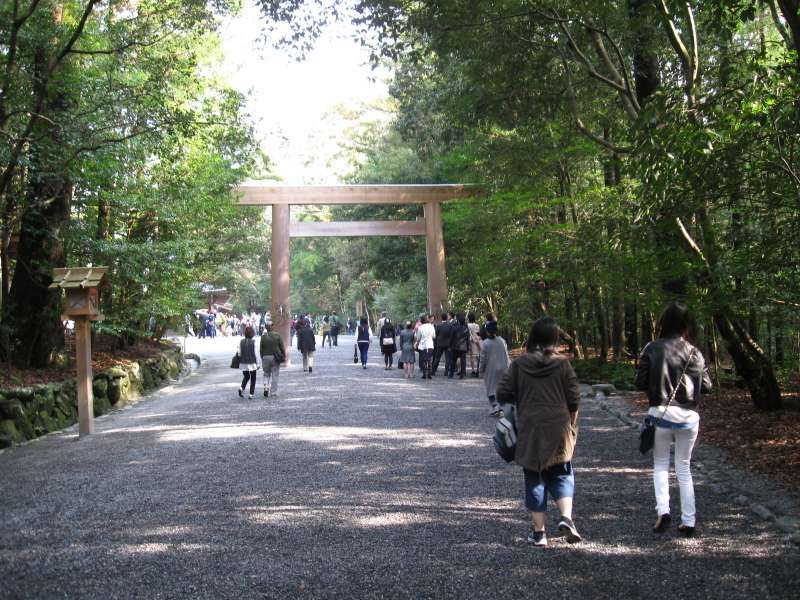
0, 0, 800, 411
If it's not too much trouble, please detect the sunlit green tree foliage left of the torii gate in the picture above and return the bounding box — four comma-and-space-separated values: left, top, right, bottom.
0, 0, 269, 346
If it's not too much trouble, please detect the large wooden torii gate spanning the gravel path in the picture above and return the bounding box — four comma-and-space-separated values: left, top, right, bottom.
237, 182, 478, 347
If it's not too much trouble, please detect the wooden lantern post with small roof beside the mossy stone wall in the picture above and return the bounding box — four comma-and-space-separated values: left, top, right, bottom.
50, 267, 108, 437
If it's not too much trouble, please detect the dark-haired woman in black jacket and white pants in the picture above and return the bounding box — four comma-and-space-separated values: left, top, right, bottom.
636, 302, 711, 537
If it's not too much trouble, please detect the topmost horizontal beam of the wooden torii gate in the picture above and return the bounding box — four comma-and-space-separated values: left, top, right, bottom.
236, 182, 481, 205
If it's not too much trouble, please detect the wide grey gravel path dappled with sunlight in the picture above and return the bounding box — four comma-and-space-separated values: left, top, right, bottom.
0, 337, 800, 599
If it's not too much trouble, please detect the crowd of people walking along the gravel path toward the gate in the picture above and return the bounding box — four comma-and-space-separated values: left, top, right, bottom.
231, 303, 711, 547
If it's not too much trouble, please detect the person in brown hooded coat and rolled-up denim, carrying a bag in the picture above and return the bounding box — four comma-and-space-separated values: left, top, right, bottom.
497, 317, 581, 546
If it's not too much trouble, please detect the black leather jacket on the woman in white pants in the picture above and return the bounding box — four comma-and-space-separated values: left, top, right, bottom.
635, 337, 712, 409
